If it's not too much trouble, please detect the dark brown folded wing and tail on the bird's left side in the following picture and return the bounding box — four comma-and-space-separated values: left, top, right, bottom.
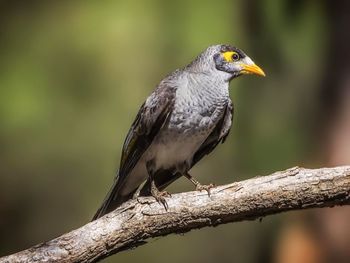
93, 83, 176, 220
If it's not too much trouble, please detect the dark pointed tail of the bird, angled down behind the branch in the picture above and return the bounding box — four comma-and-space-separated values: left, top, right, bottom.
91, 178, 137, 221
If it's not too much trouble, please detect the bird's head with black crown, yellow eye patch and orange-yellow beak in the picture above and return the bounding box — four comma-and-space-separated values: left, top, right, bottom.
189, 45, 265, 80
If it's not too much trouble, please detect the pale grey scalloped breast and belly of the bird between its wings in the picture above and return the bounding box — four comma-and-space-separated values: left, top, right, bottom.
149, 71, 229, 169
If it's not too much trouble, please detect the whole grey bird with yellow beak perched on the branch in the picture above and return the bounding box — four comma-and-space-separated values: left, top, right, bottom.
93, 45, 265, 220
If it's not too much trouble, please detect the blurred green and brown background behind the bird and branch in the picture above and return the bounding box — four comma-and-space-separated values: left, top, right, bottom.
0, 0, 350, 263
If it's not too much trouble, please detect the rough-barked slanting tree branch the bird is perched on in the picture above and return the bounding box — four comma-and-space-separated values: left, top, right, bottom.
0, 166, 350, 263
